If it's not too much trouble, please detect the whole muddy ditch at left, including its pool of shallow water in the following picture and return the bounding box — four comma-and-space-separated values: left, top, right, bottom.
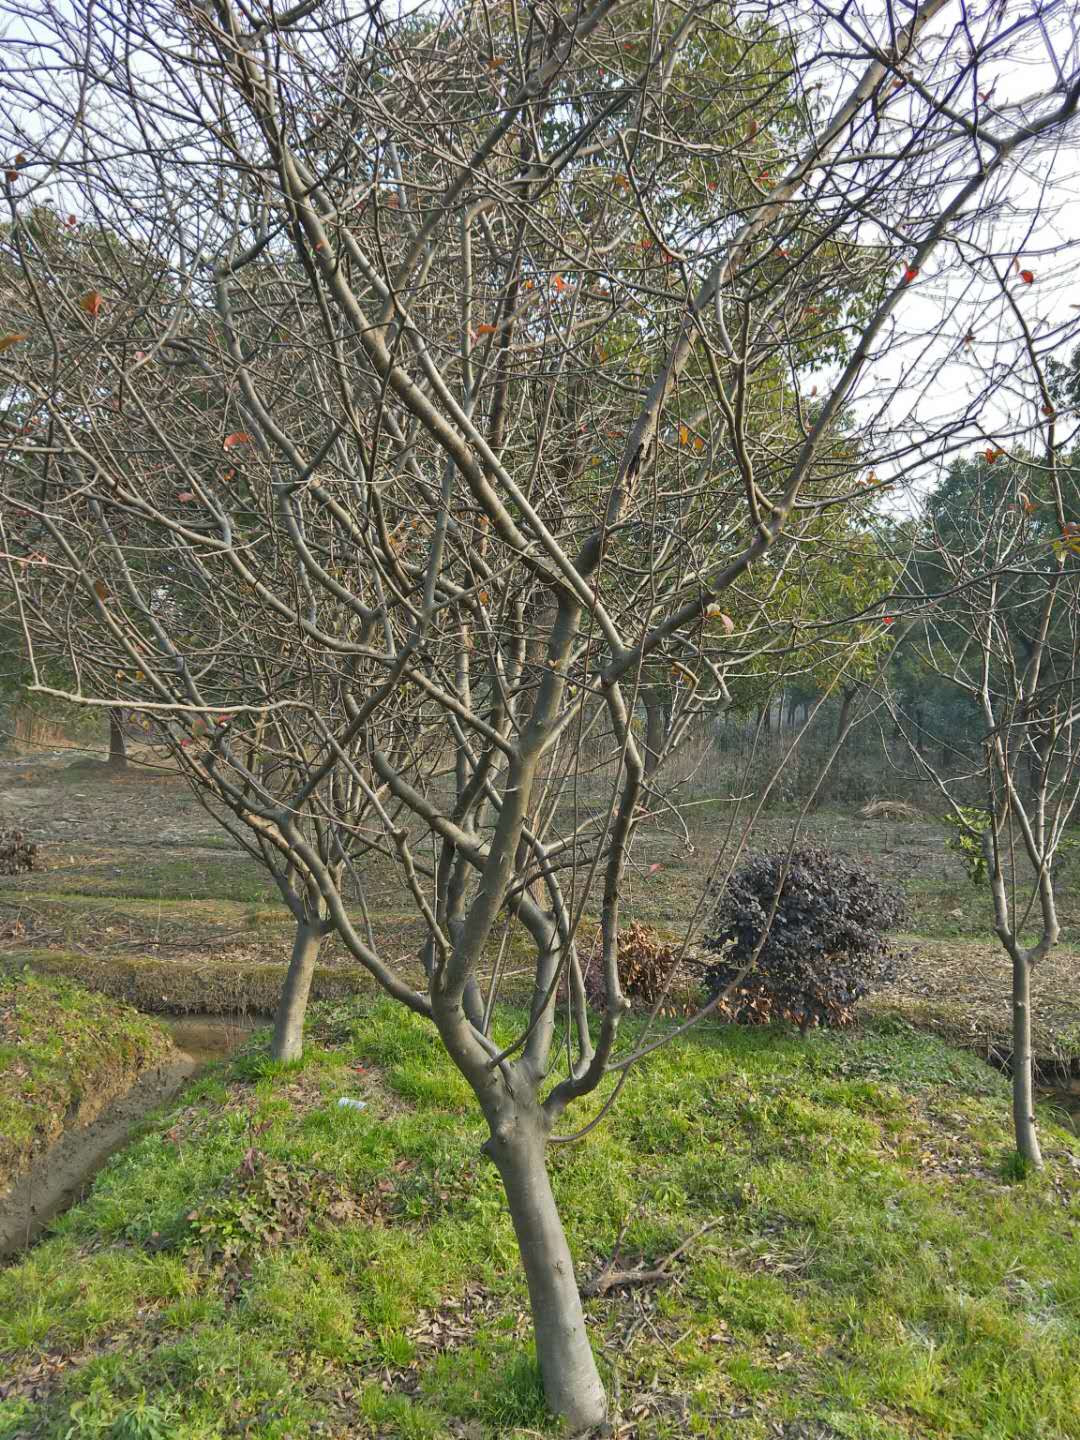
0, 1015, 256, 1259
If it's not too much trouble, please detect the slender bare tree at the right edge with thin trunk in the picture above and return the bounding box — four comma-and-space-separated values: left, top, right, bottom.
893, 434, 1080, 1166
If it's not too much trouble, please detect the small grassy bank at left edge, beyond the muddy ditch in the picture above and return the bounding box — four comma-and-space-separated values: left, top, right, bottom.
0, 972, 171, 1192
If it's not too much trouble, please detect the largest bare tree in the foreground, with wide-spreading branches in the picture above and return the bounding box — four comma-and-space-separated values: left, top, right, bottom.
0, 0, 1080, 1430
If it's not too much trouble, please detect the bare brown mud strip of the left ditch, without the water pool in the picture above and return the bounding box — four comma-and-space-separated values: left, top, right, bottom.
0, 1053, 197, 1257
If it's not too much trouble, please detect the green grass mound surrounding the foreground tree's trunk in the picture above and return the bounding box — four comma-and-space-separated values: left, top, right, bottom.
0, 1001, 1080, 1440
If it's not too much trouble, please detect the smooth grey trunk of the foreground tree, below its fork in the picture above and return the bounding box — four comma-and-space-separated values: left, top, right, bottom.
485, 1110, 608, 1434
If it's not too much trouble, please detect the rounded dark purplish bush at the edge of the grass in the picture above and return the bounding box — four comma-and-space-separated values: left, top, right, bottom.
706, 845, 906, 1030
